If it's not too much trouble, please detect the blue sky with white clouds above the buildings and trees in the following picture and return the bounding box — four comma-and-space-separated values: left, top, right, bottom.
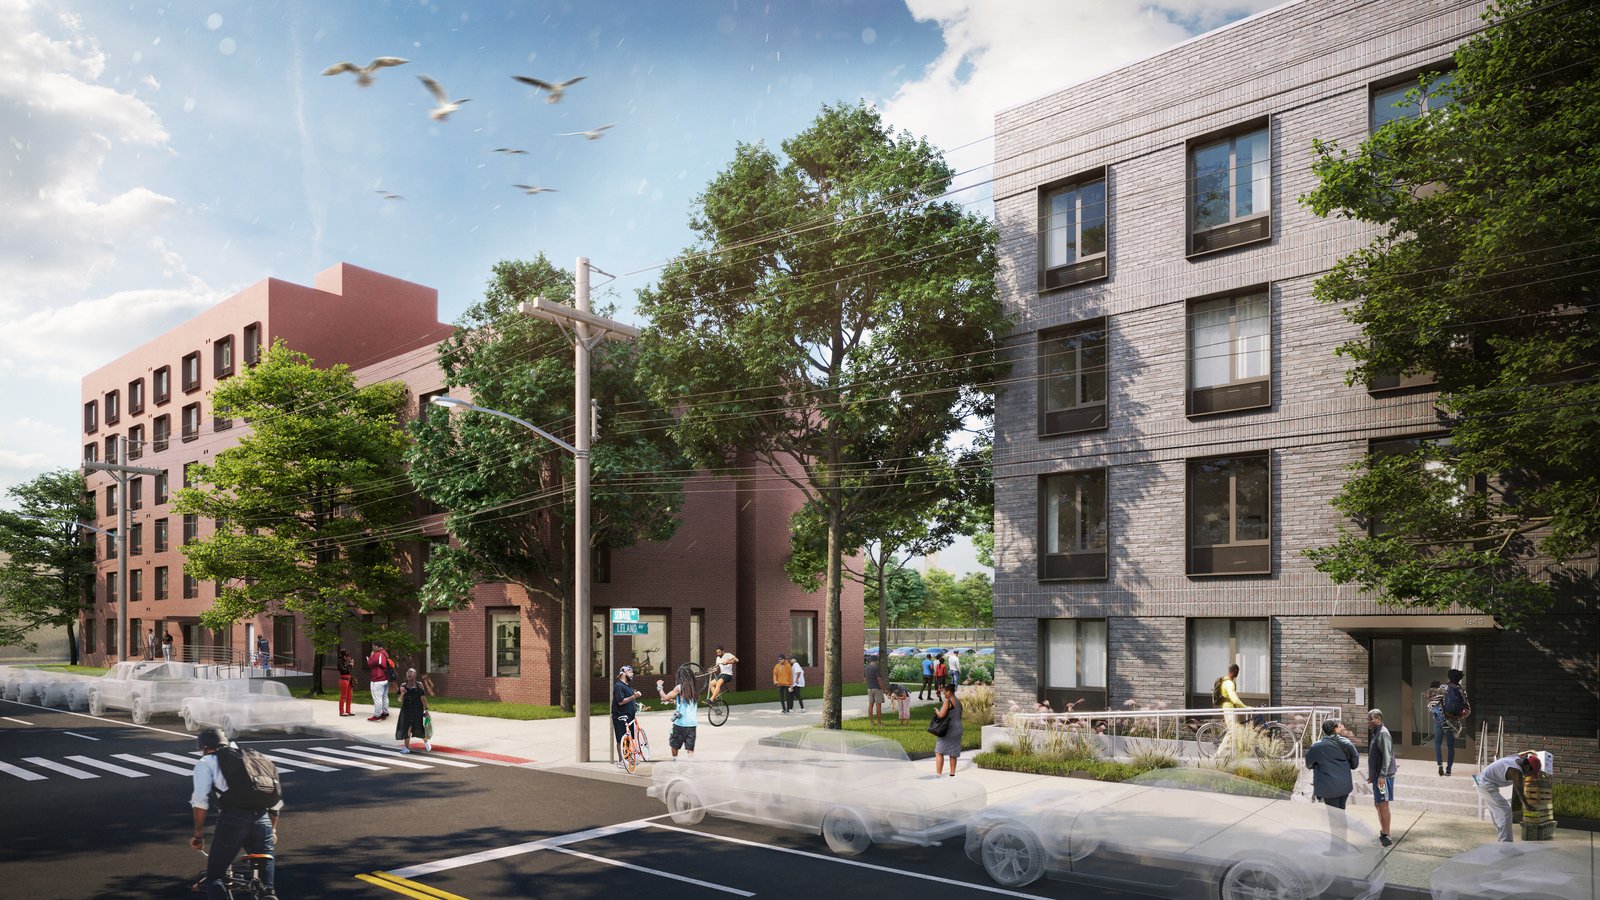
0, 0, 1277, 573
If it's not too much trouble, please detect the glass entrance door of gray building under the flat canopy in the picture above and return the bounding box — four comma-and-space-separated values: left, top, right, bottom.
1371, 636, 1474, 761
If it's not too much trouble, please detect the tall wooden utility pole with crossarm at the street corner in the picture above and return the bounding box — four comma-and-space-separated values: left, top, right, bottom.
522, 256, 638, 762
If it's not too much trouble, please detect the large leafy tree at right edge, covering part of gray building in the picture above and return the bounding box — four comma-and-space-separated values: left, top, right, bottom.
1302, 0, 1600, 625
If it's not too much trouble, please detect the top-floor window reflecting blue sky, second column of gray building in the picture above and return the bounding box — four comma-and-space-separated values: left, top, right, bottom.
1189, 120, 1272, 256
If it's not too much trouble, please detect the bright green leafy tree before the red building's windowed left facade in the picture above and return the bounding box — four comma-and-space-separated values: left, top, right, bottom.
173, 341, 416, 693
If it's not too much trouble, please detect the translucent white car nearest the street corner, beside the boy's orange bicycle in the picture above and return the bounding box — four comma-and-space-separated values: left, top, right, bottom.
650, 729, 987, 857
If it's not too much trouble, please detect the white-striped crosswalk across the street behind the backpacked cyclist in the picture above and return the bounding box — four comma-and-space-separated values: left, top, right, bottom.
0, 745, 478, 783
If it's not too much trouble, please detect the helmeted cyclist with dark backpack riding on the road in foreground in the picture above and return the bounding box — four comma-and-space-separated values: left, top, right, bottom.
189, 729, 283, 900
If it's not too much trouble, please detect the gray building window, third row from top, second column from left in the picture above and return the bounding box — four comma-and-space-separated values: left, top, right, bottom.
1187, 452, 1272, 575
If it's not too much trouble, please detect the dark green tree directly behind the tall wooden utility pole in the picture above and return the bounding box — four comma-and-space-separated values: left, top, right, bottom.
408, 253, 690, 711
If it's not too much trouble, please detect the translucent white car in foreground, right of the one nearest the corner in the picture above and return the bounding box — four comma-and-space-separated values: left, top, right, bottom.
966, 769, 1384, 900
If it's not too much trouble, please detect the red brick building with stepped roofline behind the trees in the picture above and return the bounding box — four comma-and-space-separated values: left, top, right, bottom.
82, 263, 864, 703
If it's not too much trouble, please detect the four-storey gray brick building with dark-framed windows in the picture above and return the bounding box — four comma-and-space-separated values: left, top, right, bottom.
994, 0, 1600, 780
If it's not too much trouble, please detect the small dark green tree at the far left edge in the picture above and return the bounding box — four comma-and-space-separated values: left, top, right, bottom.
0, 469, 94, 665
